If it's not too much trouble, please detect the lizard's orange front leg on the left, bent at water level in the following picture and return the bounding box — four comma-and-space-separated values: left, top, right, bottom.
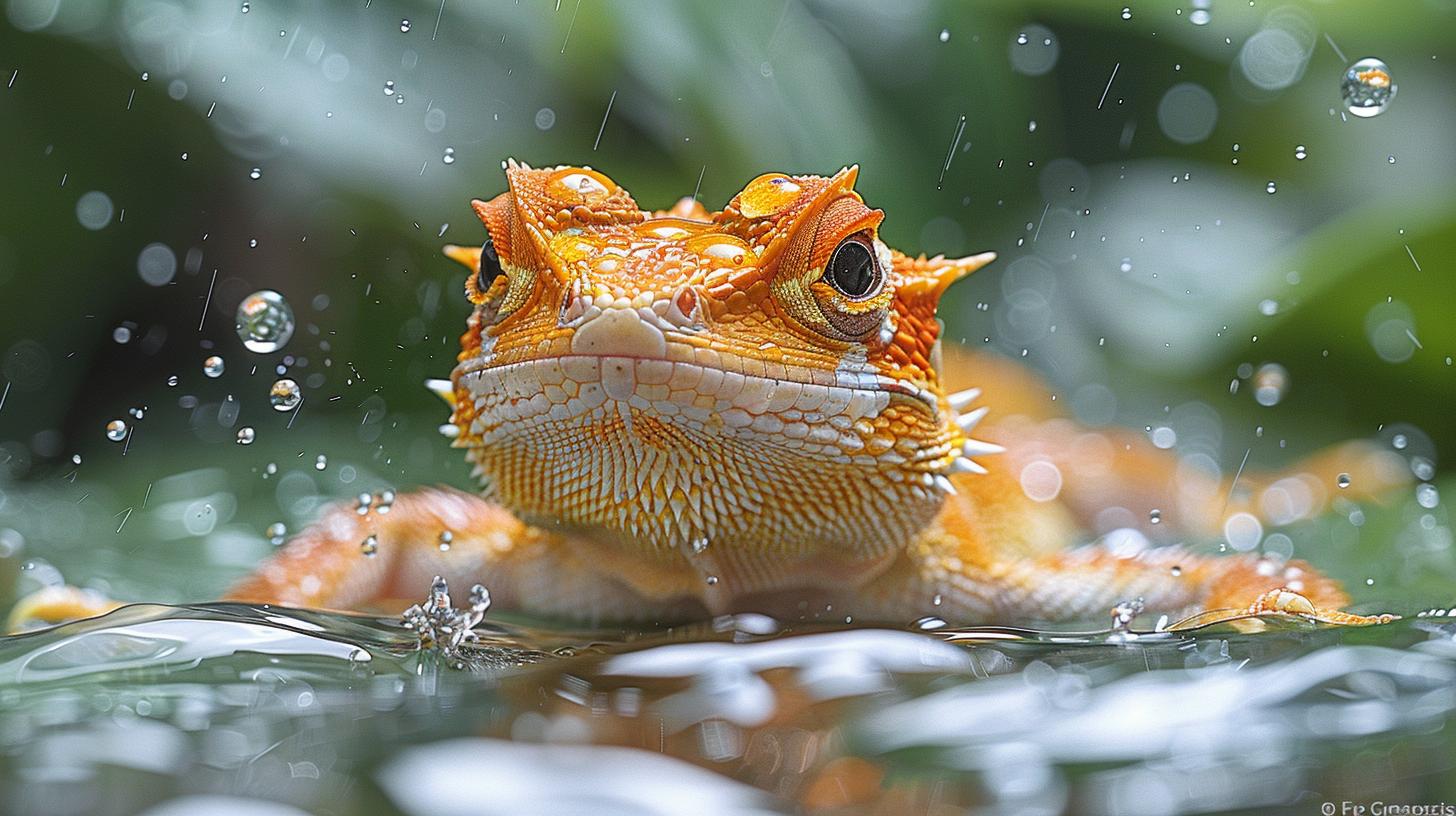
226, 488, 704, 622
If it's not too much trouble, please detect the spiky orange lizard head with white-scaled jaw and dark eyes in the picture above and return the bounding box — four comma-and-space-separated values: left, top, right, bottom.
441, 162, 993, 568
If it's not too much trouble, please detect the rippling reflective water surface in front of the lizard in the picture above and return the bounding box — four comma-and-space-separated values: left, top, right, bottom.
0, 605, 1456, 813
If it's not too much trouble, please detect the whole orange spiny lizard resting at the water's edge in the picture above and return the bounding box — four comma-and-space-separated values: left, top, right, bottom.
11, 162, 1404, 624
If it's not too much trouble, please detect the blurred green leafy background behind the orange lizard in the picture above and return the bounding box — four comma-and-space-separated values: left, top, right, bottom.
0, 0, 1456, 600
